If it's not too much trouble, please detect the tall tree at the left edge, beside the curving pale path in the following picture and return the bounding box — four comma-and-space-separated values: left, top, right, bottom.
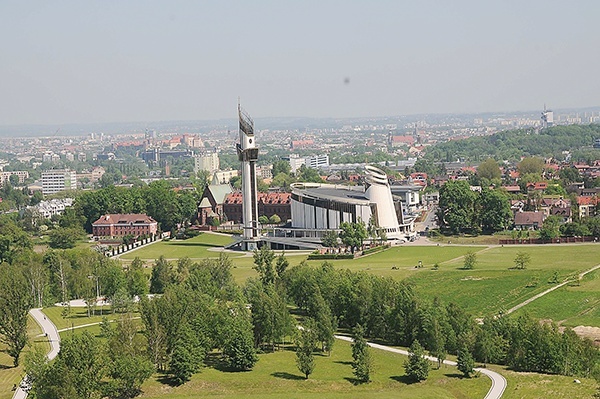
0, 263, 33, 367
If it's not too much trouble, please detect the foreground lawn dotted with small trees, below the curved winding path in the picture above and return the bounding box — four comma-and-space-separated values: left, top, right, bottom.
141, 341, 491, 399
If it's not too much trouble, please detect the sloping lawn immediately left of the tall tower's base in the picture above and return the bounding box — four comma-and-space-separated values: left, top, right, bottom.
120, 233, 241, 261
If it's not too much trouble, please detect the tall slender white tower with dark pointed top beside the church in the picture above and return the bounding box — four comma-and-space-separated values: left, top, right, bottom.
236, 103, 258, 250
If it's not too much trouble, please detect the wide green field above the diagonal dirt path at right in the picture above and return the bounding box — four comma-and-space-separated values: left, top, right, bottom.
408, 245, 600, 318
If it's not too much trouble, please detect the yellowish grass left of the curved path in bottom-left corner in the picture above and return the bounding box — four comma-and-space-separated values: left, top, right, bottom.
0, 316, 50, 399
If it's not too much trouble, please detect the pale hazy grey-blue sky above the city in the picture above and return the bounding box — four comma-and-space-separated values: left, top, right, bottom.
0, 0, 600, 125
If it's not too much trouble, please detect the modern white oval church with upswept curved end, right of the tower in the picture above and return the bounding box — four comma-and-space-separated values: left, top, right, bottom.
291, 166, 415, 241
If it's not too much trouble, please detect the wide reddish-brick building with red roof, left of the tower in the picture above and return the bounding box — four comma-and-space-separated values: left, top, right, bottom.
92, 213, 158, 237
